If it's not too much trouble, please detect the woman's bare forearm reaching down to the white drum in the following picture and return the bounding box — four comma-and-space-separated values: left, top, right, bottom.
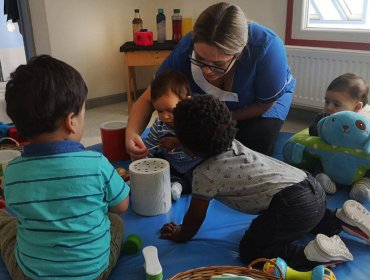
126, 86, 154, 160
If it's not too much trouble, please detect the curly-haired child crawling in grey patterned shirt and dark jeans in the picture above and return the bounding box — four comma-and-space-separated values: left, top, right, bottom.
161, 95, 370, 268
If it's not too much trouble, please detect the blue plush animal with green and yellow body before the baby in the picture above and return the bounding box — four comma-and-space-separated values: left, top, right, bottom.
283, 111, 370, 203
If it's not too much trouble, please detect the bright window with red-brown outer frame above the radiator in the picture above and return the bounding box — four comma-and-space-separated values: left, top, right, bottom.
285, 0, 370, 51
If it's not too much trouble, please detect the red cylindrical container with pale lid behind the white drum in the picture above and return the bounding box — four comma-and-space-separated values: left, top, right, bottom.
100, 121, 130, 161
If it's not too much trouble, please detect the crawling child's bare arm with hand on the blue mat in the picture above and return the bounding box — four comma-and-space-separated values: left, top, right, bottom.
161, 198, 209, 242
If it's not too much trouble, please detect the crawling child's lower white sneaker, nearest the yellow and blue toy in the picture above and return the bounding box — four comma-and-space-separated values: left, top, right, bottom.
304, 233, 353, 264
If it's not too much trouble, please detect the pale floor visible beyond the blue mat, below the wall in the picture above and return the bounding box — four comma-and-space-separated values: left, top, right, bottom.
81, 102, 315, 147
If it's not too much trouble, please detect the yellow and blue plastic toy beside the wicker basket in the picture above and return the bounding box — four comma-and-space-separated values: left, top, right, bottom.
263, 258, 336, 280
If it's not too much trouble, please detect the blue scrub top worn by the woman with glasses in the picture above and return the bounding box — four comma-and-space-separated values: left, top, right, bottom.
157, 23, 295, 120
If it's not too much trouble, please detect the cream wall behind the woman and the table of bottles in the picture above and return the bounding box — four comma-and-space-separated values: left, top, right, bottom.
29, 0, 287, 98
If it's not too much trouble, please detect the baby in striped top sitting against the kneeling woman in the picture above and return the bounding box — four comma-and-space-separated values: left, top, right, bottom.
144, 69, 201, 200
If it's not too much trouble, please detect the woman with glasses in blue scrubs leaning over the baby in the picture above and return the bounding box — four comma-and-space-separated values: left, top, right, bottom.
126, 2, 295, 160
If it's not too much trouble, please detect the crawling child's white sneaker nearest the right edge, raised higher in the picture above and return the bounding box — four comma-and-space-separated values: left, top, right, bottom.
335, 200, 370, 243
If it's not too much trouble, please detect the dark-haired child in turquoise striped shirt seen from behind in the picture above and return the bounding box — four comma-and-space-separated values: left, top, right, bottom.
0, 55, 130, 279
